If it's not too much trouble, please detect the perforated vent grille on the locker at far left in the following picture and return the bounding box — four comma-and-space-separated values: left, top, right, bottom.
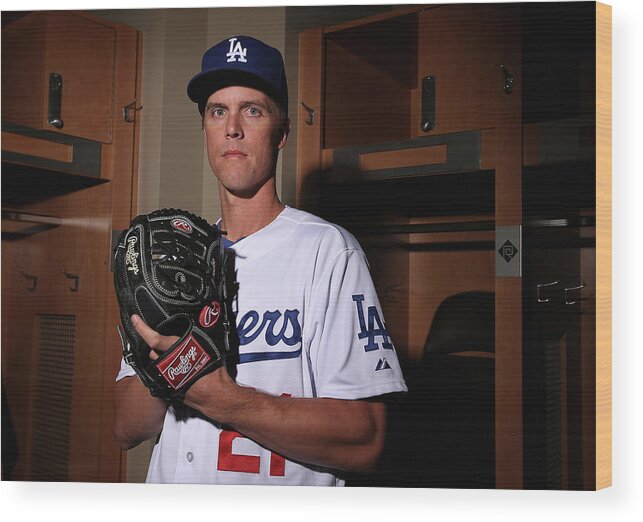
31, 315, 76, 482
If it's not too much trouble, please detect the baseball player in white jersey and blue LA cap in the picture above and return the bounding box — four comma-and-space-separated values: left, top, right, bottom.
114, 36, 406, 486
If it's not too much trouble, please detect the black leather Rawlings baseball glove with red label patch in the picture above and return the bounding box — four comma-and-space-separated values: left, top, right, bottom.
114, 209, 232, 402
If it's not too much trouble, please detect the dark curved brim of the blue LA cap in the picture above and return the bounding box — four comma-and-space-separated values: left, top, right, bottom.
187, 69, 283, 114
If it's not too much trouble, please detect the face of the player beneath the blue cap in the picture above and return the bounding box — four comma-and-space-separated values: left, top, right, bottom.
203, 86, 288, 197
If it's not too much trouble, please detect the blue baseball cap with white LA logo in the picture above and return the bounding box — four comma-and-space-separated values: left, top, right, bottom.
188, 35, 288, 114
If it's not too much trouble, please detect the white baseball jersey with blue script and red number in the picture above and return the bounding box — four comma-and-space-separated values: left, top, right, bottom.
118, 203, 406, 486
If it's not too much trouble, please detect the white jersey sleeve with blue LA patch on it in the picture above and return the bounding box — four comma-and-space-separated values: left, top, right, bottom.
304, 248, 407, 399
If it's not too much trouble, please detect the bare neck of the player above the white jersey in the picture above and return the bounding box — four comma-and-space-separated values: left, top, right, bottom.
219, 183, 284, 241
